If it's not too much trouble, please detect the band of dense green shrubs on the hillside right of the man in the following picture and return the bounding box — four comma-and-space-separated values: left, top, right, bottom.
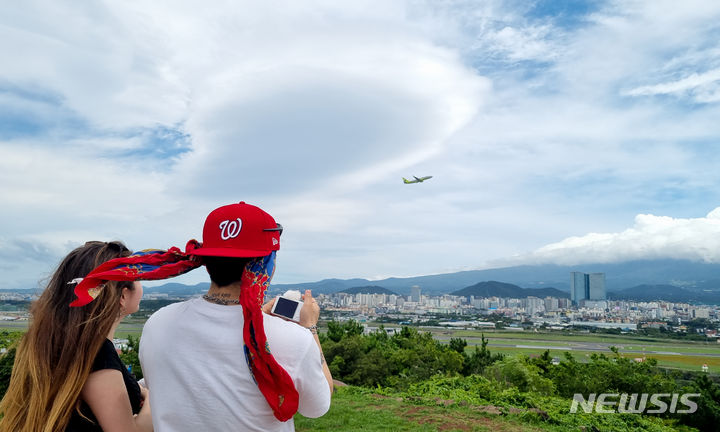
323, 322, 720, 431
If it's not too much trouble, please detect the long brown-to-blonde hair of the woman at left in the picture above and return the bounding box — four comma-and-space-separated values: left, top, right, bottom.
0, 242, 133, 432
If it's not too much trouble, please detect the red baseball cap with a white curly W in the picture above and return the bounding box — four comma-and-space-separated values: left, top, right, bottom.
190, 201, 282, 257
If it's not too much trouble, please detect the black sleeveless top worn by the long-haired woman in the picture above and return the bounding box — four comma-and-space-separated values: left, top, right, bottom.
65, 339, 142, 432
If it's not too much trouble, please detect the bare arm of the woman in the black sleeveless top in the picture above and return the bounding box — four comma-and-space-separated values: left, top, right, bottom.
80, 369, 153, 432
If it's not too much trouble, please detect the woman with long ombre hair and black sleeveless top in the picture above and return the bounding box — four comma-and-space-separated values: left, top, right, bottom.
0, 241, 152, 432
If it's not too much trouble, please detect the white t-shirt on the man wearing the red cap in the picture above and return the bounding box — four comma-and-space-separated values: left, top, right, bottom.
139, 298, 330, 432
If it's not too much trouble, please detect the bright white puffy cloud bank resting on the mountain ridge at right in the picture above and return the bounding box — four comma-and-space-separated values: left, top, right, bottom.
517, 207, 720, 265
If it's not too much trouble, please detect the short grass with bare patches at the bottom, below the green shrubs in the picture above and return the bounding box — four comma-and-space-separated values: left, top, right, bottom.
295, 388, 558, 432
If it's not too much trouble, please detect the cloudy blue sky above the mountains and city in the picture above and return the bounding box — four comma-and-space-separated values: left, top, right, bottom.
0, 0, 720, 288
